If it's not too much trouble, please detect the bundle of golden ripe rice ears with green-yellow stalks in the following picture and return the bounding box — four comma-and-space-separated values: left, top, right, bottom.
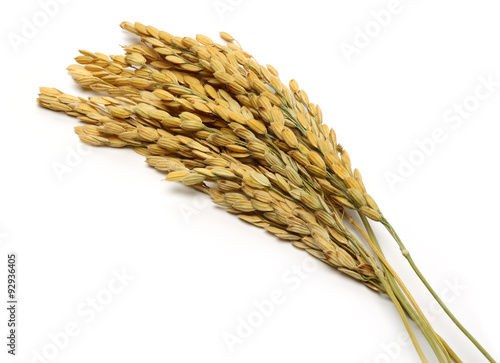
37, 22, 494, 362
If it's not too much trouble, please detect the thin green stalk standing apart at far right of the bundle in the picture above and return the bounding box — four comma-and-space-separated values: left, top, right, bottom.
380, 217, 496, 363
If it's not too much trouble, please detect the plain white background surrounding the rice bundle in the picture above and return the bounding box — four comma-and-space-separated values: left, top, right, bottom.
0, 0, 500, 363
